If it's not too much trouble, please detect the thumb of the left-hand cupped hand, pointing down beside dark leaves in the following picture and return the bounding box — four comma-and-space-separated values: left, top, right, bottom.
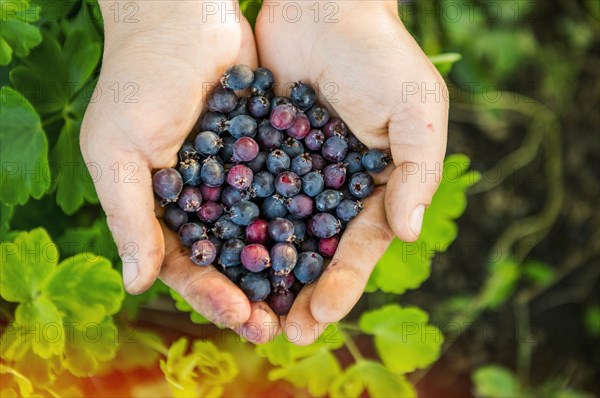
81, 121, 164, 294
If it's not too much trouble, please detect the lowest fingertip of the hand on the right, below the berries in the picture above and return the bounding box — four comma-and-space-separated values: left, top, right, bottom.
282, 284, 328, 346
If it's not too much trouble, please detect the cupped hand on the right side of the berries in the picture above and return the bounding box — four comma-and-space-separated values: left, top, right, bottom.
256, 0, 448, 344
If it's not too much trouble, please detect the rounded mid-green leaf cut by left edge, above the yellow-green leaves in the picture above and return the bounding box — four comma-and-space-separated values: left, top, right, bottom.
0, 86, 50, 206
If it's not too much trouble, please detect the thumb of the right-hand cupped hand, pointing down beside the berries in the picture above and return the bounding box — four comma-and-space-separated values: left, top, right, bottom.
385, 64, 448, 242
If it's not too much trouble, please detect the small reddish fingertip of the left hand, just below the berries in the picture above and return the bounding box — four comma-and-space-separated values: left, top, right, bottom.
234, 302, 281, 344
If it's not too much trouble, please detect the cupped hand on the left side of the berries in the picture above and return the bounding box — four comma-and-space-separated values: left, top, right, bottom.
81, 0, 279, 341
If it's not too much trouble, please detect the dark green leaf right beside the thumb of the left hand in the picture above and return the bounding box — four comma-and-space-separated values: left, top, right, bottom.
50, 118, 98, 214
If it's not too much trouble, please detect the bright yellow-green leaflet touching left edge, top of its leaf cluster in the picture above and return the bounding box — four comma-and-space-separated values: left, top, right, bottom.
0, 228, 58, 303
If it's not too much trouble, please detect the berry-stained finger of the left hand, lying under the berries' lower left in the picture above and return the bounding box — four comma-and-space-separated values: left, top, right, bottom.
160, 225, 251, 329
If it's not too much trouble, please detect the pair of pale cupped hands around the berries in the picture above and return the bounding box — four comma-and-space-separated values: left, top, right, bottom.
81, 1, 448, 344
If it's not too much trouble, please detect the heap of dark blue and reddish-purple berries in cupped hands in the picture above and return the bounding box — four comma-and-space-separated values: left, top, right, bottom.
153, 65, 389, 315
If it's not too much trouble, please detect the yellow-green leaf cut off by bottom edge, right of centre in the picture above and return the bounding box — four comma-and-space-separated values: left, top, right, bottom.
330, 360, 417, 398
